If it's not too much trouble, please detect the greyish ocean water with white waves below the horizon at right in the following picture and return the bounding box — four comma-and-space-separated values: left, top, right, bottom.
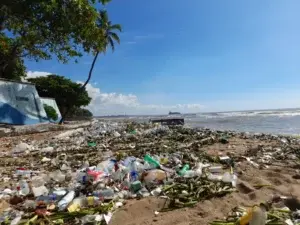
108, 109, 300, 135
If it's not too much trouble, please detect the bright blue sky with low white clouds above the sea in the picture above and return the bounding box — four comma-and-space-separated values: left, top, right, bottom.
26, 0, 300, 116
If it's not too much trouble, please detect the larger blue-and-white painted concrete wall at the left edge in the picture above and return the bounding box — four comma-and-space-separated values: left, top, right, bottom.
0, 79, 49, 125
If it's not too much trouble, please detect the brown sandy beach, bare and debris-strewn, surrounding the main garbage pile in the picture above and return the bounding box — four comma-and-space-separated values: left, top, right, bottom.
0, 122, 300, 225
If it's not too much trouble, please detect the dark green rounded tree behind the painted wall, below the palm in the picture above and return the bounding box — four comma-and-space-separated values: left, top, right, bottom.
28, 74, 91, 114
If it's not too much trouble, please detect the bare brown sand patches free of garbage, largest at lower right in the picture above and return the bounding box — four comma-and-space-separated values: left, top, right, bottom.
0, 133, 300, 225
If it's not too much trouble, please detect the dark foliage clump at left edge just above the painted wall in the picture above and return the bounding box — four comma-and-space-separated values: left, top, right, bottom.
0, 33, 26, 81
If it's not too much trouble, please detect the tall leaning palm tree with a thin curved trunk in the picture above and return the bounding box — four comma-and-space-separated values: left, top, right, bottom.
59, 10, 122, 124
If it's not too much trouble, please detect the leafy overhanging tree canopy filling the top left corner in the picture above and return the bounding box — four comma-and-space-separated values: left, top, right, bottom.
0, 0, 120, 67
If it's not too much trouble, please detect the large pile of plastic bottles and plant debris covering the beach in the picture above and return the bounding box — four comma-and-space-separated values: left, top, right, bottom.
0, 122, 237, 224
